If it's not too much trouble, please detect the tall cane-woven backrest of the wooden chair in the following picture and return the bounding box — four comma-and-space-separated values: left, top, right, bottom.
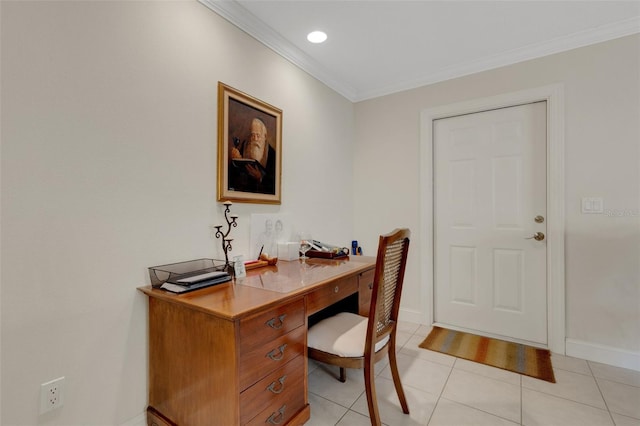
368, 229, 410, 345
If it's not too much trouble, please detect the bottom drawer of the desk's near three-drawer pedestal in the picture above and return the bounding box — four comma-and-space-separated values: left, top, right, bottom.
240, 356, 304, 424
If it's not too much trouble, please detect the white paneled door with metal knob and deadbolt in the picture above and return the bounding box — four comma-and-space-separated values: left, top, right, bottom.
433, 102, 547, 345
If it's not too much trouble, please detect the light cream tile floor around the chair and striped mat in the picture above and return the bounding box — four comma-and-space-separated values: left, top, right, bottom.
306, 322, 640, 426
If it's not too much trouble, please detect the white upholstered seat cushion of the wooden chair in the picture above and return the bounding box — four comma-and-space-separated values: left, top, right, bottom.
307, 312, 389, 357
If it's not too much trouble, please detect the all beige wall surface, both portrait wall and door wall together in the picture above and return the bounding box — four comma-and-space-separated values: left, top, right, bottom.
0, 1, 640, 425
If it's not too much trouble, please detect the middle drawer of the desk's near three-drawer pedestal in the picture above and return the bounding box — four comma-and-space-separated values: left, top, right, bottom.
240, 327, 307, 391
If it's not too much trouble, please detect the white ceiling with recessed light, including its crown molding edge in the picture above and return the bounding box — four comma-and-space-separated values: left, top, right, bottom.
200, 0, 640, 102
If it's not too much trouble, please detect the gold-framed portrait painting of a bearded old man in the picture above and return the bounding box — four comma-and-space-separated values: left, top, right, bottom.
218, 82, 282, 204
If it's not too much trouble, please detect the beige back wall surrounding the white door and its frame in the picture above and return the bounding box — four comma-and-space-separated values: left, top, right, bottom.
354, 35, 640, 356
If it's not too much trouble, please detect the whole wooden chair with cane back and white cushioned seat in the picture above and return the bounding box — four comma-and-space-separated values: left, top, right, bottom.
307, 229, 410, 425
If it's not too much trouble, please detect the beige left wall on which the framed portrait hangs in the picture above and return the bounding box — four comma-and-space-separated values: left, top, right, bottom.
0, 1, 354, 426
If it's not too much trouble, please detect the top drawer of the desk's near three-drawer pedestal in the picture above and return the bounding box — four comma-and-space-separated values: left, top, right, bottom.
240, 299, 305, 353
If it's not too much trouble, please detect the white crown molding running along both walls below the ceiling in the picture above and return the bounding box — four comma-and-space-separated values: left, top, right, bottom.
198, 0, 640, 102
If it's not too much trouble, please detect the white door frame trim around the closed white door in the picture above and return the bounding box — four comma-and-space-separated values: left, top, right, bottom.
420, 83, 566, 355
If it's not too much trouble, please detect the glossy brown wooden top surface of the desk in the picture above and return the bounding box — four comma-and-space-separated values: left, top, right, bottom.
139, 256, 375, 320
